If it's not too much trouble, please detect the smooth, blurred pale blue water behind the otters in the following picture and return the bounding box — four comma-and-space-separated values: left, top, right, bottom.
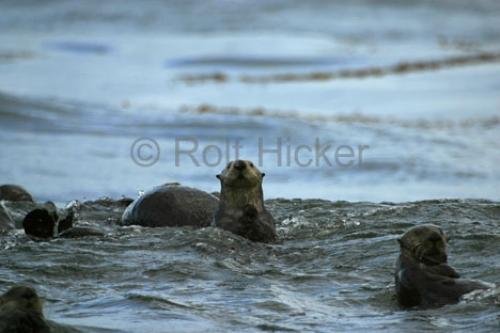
0, 0, 500, 202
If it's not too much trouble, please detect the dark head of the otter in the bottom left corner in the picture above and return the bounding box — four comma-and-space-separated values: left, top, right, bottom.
0, 286, 43, 315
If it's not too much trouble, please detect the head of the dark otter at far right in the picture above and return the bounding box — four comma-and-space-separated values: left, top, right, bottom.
398, 224, 448, 266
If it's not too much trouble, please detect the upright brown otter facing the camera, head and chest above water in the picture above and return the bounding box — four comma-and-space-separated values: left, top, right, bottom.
215, 160, 278, 242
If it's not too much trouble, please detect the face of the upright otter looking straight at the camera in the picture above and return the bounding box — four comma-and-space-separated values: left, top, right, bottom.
217, 160, 265, 187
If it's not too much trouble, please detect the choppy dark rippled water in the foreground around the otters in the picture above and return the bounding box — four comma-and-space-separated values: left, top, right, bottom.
0, 199, 500, 332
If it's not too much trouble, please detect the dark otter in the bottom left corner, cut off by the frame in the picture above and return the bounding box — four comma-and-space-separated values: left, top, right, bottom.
0, 286, 51, 333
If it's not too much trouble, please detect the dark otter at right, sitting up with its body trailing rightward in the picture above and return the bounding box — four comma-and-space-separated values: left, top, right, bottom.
395, 224, 489, 308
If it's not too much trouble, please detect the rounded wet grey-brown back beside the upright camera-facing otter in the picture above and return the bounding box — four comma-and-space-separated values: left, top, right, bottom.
122, 183, 219, 227
